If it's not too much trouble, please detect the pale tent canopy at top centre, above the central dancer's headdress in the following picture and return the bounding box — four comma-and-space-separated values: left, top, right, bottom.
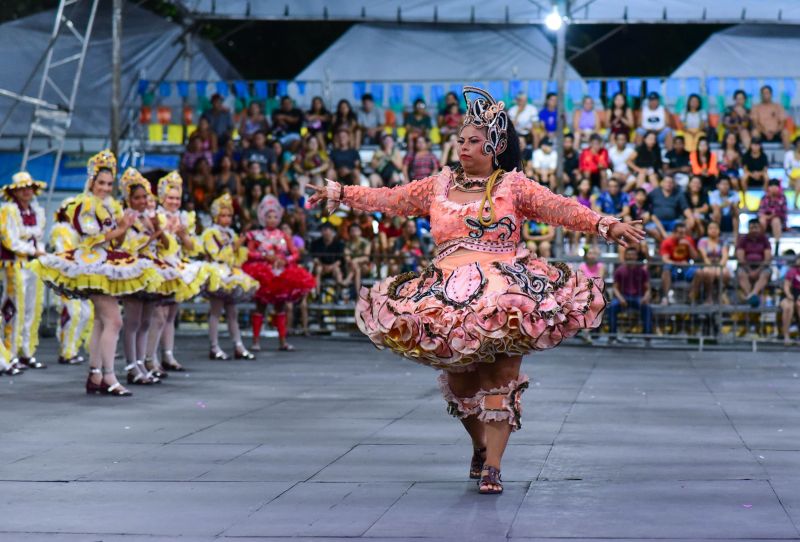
290, 23, 580, 103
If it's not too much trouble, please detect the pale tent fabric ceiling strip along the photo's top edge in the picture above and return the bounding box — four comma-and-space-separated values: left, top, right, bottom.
175, 0, 800, 24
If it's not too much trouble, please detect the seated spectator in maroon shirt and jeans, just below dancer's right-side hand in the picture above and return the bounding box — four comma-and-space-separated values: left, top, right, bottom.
608, 247, 653, 341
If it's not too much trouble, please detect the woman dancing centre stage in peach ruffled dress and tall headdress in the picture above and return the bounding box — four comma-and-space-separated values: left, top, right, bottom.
309, 87, 644, 494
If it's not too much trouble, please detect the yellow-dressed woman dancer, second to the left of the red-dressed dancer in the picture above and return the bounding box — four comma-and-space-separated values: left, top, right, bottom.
145, 171, 209, 374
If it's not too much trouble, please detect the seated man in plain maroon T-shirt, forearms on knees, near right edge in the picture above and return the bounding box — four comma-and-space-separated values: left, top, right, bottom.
736, 218, 772, 307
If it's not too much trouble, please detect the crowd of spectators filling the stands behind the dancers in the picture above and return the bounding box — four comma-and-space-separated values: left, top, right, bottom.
181, 86, 800, 340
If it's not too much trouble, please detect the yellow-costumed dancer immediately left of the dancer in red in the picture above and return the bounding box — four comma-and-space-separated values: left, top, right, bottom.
203, 194, 258, 361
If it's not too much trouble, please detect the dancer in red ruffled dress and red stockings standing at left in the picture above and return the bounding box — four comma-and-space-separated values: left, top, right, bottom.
242, 196, 317, 351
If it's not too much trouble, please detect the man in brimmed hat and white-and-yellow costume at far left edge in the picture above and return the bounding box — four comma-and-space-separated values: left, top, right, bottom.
0, 171, 46, 369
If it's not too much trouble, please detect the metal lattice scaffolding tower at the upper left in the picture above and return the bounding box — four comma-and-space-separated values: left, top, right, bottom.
0, 0, 100, 203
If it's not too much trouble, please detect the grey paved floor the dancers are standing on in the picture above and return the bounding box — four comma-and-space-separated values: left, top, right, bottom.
0, 337, 800, 542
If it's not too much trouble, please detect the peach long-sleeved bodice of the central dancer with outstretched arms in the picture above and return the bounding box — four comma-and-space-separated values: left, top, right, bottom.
328, 167, 617, 258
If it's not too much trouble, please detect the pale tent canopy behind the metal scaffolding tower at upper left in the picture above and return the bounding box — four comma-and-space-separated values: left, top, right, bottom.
0, 2, 238, 138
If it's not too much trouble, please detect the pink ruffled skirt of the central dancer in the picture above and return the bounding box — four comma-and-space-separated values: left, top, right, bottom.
356, 252, 606, 371
